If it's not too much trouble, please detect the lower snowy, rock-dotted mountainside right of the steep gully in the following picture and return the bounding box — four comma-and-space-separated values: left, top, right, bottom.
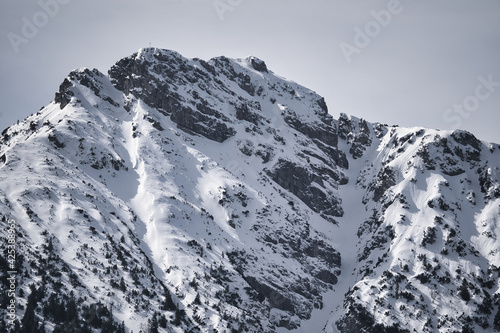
332, 117, 500, 332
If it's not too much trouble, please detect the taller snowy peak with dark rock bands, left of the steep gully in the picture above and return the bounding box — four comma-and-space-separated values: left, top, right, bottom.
1, 49, 345, 331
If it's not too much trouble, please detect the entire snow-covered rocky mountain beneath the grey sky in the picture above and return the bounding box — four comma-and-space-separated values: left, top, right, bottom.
0, 48, 500, 333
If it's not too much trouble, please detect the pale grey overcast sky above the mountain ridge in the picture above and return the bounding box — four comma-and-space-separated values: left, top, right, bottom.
0, 0, 500, 143
